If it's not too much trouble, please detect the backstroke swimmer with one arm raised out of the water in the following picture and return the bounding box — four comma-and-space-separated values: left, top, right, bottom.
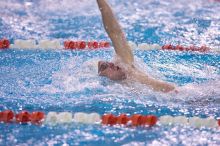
97, 0, 176, 93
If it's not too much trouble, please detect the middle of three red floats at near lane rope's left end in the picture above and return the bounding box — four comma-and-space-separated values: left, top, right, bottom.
15, 111, 31, 124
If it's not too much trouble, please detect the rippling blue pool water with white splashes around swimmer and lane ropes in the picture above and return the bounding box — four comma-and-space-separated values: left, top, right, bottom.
0, 0, 220, 145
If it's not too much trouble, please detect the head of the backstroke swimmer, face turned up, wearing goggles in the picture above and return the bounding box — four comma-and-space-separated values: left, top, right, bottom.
98, 61, 126, 81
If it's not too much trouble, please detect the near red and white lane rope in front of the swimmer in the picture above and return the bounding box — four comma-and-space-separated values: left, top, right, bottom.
0, 110, 220, 128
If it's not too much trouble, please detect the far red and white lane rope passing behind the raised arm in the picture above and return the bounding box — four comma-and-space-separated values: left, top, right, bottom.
0, 38, 220, 53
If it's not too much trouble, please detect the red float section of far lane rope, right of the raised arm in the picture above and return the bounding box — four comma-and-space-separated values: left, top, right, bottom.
162, 44, 210, 52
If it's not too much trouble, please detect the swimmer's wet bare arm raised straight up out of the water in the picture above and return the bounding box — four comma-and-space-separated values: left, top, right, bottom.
97, 0, 134, 65
